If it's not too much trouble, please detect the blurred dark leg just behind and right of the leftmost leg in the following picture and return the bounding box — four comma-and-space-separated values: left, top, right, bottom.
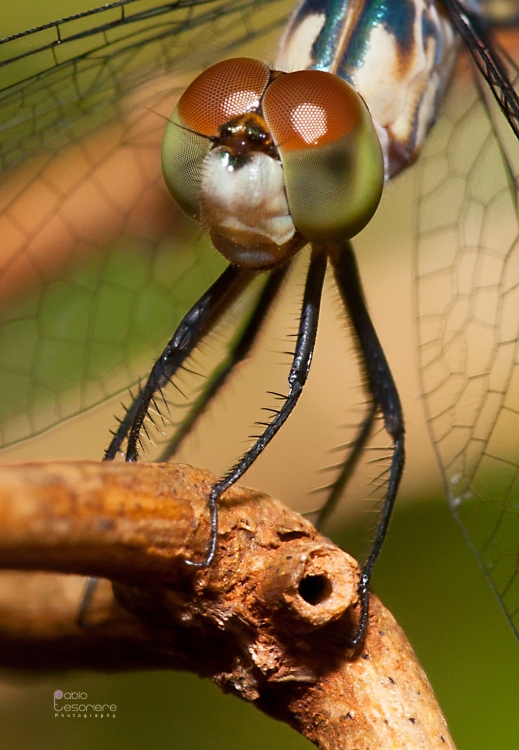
158, 264, 290, 461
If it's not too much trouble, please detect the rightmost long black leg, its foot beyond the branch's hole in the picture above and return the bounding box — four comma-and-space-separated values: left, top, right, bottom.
330, 242, 405, 645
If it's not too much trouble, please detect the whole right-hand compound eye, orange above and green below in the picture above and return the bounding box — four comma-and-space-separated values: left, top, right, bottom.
263, 70, 384, 242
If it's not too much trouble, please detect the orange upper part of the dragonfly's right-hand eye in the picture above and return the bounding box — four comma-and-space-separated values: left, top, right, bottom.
263, 70, 363, 153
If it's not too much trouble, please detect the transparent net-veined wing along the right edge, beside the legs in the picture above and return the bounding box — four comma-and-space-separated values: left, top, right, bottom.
416, 45, 519, 633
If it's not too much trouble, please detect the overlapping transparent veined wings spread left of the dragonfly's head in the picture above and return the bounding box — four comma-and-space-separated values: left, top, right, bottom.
0, 0, 292, 447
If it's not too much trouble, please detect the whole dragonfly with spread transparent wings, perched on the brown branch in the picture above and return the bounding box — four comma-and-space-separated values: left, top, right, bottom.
0, 0, 519, 642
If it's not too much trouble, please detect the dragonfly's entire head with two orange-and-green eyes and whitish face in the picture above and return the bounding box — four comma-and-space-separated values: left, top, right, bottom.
162, 58, 384, 269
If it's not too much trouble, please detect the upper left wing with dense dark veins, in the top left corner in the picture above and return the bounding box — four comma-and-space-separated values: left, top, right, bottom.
0, 0, 288, 172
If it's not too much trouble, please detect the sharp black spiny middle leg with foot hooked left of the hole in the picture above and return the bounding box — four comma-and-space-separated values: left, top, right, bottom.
186, 248, 326, 568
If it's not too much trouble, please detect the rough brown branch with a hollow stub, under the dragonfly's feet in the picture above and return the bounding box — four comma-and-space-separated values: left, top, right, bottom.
0, 462, 454, 750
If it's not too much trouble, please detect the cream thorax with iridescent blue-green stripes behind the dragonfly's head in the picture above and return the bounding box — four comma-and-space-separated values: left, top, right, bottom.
277, 0, 458, 179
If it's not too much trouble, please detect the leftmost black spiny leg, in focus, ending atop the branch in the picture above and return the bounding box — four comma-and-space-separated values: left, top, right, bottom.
104, 266, 254, 461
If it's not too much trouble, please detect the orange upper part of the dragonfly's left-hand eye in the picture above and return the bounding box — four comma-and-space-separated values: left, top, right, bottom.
177, 57, 270, 136
